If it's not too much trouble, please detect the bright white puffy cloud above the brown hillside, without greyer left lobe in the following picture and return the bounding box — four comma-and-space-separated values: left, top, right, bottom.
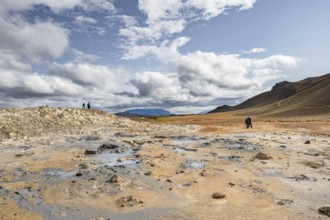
176, 51, 299, 97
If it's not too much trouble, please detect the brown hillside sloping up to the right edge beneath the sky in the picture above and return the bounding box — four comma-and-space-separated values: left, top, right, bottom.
209, 74, 330, 116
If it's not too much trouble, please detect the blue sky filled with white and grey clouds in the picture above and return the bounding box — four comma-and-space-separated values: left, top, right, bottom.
0, 0, 330, 114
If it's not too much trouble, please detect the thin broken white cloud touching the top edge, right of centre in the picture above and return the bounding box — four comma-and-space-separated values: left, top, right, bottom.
119, 0, 256, 59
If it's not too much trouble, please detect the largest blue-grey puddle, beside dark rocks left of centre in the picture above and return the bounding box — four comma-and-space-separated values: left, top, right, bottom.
88, 150, 140, 167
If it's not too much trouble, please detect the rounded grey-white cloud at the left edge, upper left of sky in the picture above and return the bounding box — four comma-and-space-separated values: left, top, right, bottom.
0, 17, 69, 62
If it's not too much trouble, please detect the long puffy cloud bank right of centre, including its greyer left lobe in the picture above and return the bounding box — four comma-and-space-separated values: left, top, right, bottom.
131, 51, 299, 106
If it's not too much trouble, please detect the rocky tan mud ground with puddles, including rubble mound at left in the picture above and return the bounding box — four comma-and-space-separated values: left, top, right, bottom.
0, 107, 330, 220
